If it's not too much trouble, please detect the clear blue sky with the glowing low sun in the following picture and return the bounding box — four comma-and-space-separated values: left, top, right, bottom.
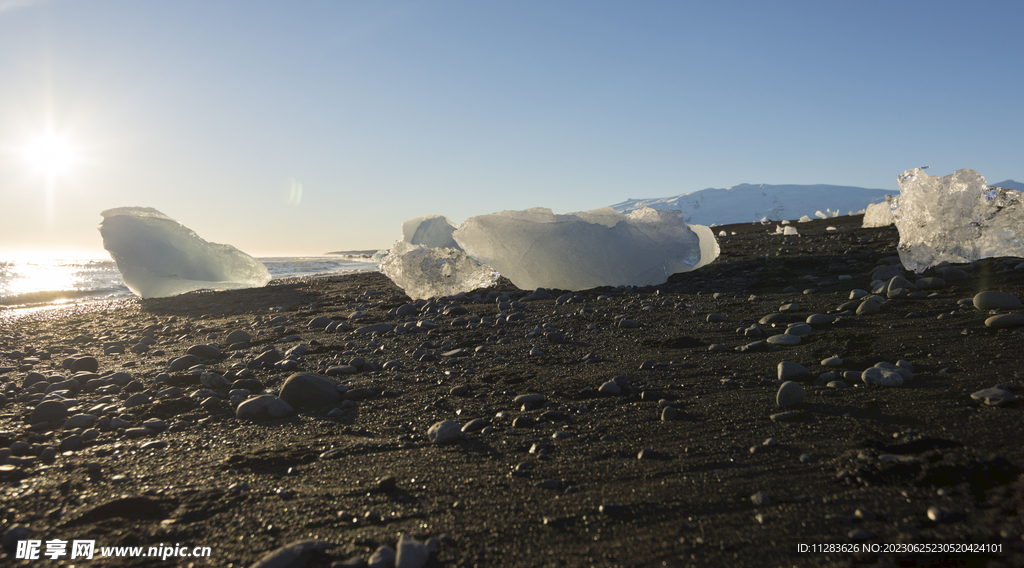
0, 0, 1024, 257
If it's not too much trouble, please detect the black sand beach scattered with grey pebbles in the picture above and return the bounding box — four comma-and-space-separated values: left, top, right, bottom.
0, 216, 1024, 567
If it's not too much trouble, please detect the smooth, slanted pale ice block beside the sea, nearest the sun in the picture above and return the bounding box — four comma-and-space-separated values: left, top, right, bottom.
99, 207, 270, 298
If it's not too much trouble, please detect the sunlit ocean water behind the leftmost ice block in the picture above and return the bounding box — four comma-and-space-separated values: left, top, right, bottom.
0, 255, 377, 310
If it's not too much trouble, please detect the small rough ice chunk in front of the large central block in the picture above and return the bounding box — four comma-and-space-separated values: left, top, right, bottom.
380, 241, 498, 300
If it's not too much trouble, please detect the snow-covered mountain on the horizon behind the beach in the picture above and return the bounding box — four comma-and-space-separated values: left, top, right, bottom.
611, 183, 892, 225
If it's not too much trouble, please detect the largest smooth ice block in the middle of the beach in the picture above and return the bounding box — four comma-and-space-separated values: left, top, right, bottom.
455, 208, 720, 291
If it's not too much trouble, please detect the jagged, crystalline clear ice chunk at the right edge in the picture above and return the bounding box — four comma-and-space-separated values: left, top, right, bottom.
893, 169, 1024, 273
